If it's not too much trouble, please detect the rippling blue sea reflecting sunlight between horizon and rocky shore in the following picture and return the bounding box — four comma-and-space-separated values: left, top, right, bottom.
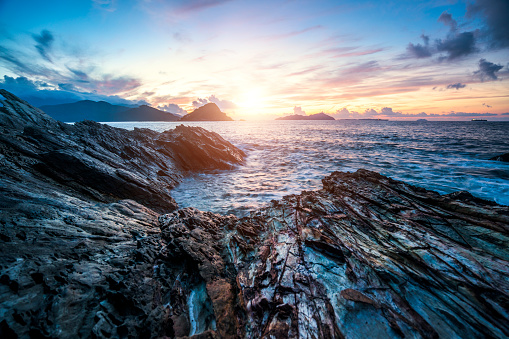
108, 120, 509, 216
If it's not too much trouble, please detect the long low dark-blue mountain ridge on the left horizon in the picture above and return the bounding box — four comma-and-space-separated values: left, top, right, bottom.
39, 100, 180, 122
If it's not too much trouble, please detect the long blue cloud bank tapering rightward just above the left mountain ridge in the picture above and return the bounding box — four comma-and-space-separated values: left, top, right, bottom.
0, 75, 148, 106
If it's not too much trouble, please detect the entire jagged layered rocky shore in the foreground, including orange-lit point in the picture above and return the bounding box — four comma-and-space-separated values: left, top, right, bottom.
0, 90, 509, 338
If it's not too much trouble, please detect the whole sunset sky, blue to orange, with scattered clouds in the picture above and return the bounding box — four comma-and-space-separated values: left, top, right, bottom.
0, 0, 509, 120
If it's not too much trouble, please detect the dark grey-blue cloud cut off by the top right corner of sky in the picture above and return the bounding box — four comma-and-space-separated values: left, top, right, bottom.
467, 0, 509, 48
